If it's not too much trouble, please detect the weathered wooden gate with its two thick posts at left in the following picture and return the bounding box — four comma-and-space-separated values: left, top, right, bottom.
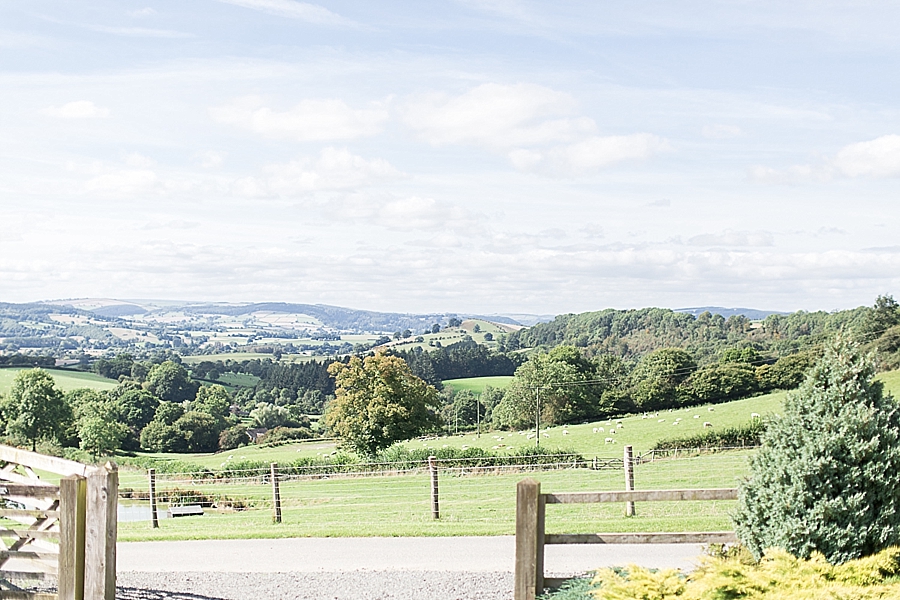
0, 446, 118, 600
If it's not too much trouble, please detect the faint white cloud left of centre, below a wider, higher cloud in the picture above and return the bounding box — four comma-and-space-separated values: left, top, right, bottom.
233, 148, 402, 196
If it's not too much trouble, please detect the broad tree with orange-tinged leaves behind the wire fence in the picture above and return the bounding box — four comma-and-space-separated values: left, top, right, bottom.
325, 352, 440, 456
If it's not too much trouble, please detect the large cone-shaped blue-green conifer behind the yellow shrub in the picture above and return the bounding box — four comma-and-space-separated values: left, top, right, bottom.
734, 338, 900, 563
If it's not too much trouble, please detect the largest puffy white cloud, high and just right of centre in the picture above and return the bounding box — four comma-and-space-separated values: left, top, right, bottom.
403, 83, 595, 149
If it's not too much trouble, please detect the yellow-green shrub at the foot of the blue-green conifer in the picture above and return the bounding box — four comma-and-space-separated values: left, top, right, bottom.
592, 547, 900, 600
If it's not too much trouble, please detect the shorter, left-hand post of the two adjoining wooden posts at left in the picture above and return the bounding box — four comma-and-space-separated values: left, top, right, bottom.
57, 475, 87, 600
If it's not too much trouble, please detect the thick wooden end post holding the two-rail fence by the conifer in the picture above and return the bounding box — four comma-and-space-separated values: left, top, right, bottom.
514, 478, 545, 600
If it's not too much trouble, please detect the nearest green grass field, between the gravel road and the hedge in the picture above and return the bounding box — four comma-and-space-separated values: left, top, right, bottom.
119, 452, 749, 541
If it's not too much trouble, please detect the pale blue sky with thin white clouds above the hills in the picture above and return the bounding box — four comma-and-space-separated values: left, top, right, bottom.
0, 0, 900, 314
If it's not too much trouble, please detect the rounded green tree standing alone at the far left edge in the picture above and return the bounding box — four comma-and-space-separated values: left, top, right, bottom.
0, 369, 72, 451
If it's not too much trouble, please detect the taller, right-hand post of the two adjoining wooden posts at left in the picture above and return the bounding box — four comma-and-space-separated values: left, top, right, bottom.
84, 462, 119, 600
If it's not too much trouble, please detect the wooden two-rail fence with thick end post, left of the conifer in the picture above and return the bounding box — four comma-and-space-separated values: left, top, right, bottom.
515, 478, 737, 600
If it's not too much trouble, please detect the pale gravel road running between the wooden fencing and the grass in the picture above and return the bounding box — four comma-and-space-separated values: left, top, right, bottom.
117, 536, 702, 600
